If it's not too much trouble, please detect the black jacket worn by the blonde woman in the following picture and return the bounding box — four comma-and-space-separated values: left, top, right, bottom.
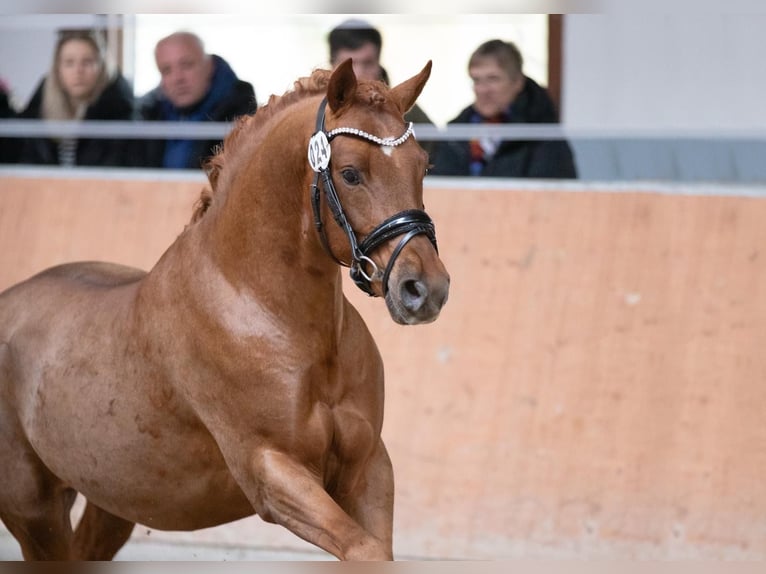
16, 75, 135, 167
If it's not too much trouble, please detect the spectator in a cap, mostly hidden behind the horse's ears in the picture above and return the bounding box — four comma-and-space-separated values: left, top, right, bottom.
327, 19, 433, 151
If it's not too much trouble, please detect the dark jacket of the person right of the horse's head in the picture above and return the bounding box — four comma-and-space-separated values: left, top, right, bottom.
430, 78, 577, 178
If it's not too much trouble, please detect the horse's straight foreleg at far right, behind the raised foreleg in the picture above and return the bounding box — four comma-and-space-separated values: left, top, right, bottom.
336, 440, 394, 548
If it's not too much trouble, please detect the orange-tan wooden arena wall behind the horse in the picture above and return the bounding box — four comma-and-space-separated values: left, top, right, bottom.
0, 173, 766, 560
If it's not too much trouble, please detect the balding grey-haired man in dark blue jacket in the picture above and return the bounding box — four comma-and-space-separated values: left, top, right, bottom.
139, 32, 257, 169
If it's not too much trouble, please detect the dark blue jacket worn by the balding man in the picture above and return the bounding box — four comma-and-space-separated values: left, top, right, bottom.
139, 55, 257, 169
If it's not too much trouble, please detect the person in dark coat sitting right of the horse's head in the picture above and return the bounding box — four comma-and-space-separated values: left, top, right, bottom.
430, 40, 577, 178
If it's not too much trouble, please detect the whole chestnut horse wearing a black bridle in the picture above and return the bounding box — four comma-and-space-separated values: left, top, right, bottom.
0, 60, 449, 560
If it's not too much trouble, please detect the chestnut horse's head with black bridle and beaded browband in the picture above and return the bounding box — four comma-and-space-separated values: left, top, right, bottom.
308, 60, 449, 324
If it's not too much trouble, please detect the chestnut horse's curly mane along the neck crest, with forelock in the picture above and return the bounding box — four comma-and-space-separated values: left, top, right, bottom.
189, 69, 386, 225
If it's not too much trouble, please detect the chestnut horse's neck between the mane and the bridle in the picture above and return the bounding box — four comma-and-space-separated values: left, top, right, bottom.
190, 104, 340, 310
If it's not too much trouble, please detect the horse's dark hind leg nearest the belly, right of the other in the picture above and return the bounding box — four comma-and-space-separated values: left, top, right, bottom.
72, 502, 135, 560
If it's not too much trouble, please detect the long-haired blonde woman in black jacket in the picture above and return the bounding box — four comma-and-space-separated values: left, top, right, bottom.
18, 31, 133, 166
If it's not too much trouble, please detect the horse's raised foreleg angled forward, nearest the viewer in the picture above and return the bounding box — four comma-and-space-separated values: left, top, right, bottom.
240, 450, 393, 560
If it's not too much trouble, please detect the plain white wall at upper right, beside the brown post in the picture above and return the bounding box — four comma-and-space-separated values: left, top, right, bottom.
562, 11, 766, 129
